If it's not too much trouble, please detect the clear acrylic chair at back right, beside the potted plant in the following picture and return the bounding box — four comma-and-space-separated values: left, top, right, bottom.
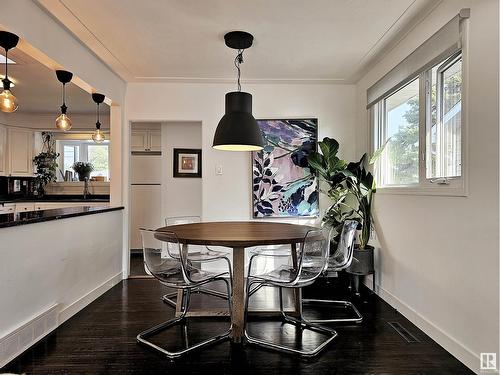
302, 220, 363, 323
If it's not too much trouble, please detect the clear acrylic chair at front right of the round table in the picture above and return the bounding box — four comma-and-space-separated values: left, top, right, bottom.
245, 230, 337, 357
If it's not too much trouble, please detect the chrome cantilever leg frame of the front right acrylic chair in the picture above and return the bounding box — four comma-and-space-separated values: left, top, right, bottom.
244, 282, 337, 357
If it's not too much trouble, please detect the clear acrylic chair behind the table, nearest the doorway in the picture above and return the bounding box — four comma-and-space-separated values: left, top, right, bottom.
162, 216, 233, 307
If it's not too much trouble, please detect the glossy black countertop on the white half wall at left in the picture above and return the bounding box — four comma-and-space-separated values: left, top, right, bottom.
0, 205, 123, 228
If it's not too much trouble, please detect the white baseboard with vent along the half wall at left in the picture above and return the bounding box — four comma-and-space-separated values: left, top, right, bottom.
0, 271, 123, 368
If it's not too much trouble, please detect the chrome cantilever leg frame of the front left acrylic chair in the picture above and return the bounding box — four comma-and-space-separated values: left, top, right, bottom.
137, 280, 232, 359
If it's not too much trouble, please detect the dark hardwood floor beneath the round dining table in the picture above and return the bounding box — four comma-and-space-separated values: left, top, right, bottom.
0, 279, 472, 375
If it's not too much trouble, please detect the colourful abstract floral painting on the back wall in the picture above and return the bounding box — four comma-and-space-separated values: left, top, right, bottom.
252, 119, 319, 218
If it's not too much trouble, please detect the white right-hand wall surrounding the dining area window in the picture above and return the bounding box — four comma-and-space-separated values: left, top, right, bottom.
356, 0, 499, 371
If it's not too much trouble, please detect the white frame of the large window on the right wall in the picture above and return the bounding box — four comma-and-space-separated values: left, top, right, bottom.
368, 48, 469, 196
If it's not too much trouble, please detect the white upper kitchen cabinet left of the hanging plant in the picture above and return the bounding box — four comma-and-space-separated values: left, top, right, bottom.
7, 128, 33, 177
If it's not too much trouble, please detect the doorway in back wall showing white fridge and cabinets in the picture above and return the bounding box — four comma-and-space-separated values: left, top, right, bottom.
129, 121, 203, 278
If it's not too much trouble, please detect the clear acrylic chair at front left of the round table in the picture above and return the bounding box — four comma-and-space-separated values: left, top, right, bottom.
137, 229, 231, 359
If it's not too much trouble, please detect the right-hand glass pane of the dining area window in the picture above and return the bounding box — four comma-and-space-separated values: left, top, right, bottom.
427, 57, 462, 178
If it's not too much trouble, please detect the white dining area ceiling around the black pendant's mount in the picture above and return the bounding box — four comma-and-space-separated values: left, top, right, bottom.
37, 0, 440, 83
